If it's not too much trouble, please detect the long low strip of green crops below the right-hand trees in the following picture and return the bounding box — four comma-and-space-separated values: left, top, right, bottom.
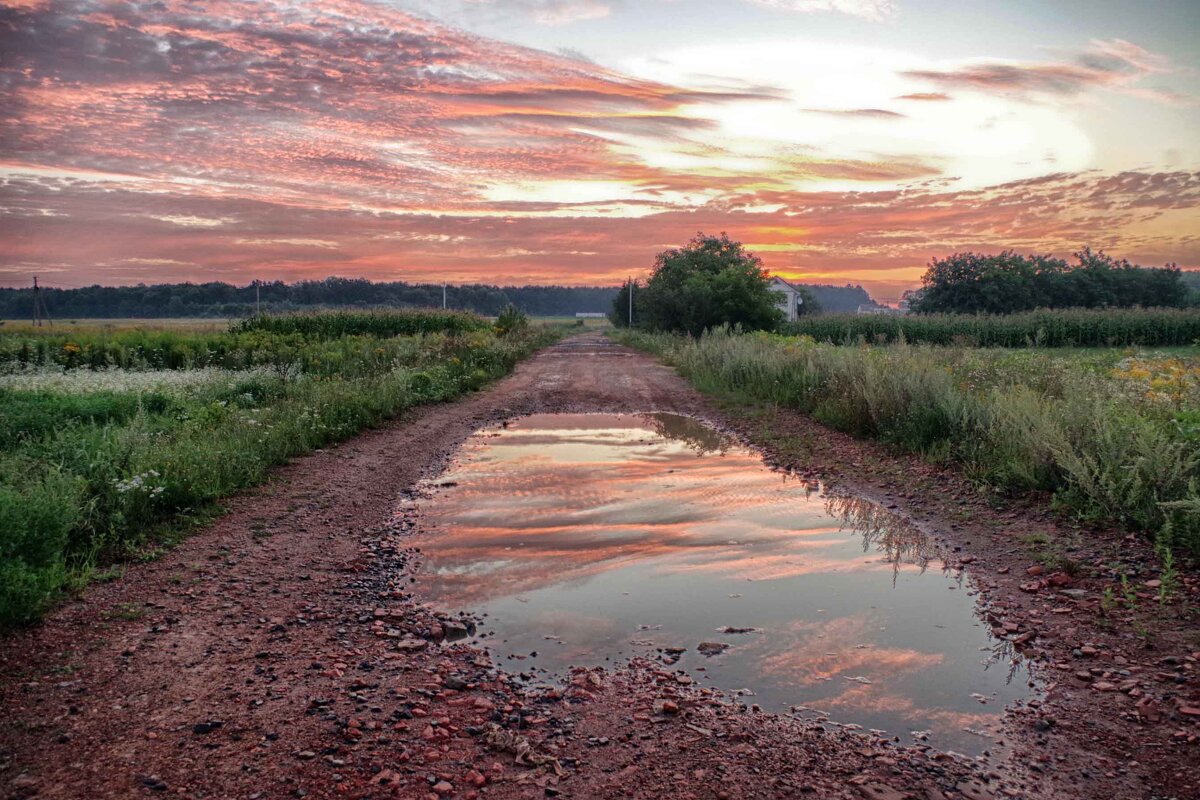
784, 308, 1200, 348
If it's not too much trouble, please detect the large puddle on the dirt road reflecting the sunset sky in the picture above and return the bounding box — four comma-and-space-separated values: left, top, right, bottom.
413, 414, 1030, 754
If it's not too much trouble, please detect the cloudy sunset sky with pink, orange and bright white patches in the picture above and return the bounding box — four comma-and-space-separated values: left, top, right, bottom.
0, 0, 1200, 302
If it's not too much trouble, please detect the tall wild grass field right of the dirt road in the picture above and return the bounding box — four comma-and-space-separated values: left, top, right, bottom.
613, 331, 1200, 558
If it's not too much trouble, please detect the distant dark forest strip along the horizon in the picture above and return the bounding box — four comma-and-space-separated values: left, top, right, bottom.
0, 278, 871, 319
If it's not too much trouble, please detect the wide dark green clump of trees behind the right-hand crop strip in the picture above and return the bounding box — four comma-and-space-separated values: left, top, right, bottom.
911, 248, 1188, 314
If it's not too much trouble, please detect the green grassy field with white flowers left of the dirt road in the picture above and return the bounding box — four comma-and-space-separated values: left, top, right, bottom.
0, 312, 560, 625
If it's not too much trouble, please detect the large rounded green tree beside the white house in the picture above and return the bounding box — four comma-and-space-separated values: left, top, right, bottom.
611, 233, 784, 336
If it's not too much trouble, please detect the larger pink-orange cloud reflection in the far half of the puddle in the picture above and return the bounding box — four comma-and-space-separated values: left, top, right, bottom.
416, 414, 940, 604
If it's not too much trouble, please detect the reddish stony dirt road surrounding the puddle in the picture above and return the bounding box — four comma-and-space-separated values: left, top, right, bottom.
0, 335, 1200, 800
